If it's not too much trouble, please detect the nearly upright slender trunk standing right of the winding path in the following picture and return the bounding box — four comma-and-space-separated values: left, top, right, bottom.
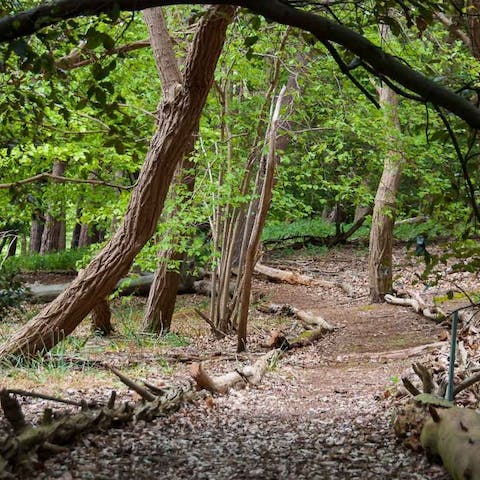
369, 25, 403, 303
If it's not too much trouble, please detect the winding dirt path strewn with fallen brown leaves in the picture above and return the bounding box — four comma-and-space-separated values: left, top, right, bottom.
31, 284, 454, 480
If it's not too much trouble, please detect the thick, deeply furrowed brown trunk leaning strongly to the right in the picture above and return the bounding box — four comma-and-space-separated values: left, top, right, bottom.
0, 6, 234, 358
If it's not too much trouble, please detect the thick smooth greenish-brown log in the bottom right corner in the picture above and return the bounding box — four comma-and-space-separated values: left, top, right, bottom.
420, 406, 480, 480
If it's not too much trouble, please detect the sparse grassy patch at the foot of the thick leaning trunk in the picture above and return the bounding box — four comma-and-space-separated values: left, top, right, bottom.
0, 298, 190, 392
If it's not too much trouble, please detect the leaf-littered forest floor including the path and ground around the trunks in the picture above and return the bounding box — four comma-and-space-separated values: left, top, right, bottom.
0, 246, 478, 480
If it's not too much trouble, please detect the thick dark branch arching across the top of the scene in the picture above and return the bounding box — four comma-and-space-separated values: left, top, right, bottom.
0, 0, 480, 129
